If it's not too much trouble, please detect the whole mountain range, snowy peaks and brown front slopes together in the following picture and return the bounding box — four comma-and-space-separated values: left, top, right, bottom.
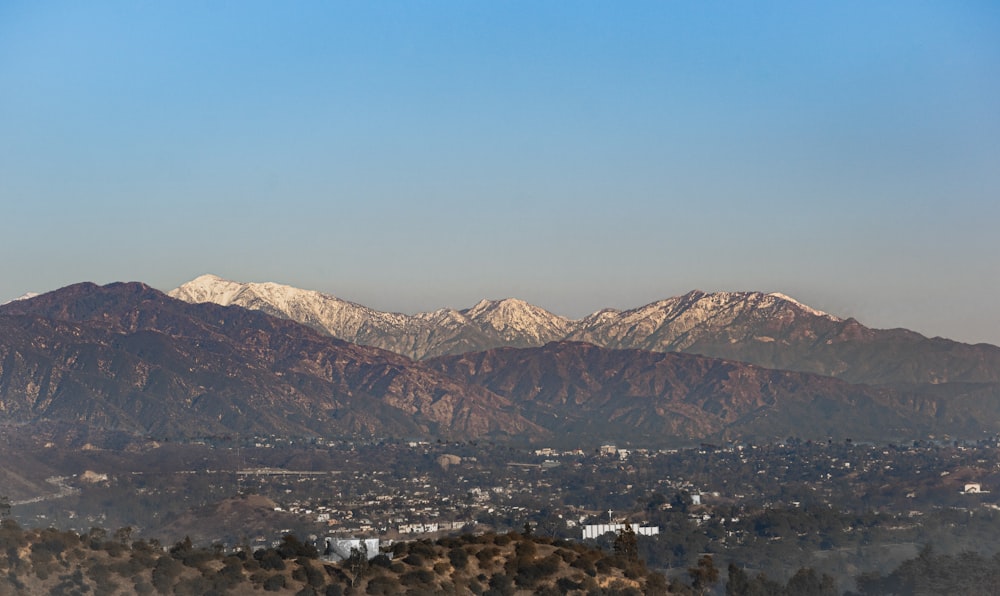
0, 276, 1000, 445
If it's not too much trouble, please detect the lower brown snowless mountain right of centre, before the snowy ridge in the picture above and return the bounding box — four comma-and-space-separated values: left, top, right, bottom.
428, 342, 968, 443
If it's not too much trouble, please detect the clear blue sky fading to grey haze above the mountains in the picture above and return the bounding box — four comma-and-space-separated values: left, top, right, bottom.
0, 0, 1000, 344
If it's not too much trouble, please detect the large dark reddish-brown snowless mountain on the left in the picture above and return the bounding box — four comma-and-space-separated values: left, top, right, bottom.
0, 283, 545, 437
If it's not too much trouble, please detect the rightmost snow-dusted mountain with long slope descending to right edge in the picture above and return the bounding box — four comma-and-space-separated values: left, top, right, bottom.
568, 291, 1000, 385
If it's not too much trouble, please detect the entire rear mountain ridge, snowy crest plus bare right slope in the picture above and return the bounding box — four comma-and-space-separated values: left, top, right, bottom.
171, 275, 1000, 386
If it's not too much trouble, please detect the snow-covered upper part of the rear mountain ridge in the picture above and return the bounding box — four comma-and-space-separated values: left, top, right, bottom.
170, 275, 860, 359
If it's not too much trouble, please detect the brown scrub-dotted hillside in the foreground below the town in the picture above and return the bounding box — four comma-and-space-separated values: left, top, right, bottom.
0, 521, 670, 595
